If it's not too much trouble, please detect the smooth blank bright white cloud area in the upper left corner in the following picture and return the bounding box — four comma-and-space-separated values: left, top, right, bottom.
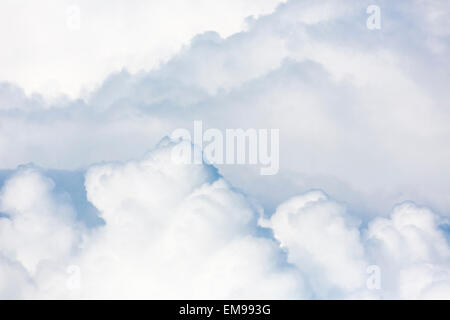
0, 0, 279, 97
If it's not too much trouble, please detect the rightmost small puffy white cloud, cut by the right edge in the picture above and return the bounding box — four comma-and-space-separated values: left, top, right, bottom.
367, 202, 450, 299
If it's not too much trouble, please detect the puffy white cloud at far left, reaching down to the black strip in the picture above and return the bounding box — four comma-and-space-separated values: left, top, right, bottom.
0, 167, 83, 299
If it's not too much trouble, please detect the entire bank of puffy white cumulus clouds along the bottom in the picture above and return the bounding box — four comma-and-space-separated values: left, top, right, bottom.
0, 141, 450, 299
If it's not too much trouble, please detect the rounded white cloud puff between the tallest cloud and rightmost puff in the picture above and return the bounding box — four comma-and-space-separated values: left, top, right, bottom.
267, 191, 367, 297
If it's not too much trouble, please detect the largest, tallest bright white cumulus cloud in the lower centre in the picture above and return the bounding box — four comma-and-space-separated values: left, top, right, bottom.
81, 141, 310, 299
